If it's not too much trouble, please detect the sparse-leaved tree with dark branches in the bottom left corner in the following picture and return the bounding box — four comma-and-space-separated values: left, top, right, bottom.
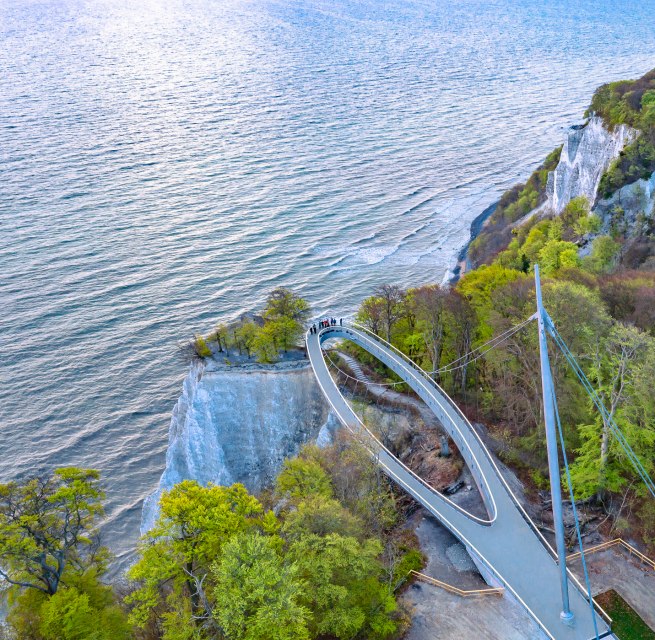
0, 468, 131, 640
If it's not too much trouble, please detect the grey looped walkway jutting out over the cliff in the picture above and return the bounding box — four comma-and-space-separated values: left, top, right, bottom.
306, 325, 608, 640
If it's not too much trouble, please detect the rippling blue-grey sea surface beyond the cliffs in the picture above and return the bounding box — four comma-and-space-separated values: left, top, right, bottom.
0, 0, 655, 566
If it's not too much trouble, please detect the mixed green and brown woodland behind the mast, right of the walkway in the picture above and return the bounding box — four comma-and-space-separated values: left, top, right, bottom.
352, 209, 655, 548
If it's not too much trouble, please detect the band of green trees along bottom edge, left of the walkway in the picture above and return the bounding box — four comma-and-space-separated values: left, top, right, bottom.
0, 436, 423, 640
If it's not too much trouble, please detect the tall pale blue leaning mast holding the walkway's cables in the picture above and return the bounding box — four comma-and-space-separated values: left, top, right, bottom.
534, 265, 573, 624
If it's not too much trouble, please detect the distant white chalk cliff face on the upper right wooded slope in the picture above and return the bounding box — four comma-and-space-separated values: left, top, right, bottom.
544, 117, 637, 213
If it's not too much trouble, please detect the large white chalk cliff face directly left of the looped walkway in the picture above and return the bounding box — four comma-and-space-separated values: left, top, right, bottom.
141, 361, 332, 533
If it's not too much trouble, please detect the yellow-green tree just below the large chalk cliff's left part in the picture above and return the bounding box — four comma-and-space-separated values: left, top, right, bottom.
127, 480, 266, 640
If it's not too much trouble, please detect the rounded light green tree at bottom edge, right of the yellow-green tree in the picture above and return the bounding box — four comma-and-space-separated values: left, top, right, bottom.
212, 533, 311, 640
